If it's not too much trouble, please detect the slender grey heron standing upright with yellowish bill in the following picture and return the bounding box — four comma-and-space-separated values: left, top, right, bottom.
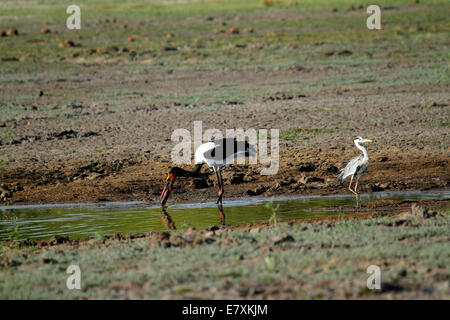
338, 137, 372, 200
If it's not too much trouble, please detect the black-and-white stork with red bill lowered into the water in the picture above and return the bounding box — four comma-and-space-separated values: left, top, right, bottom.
160, 138, 256, 207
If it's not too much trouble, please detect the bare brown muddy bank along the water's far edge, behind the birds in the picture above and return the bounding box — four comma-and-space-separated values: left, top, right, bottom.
0, 152, 450, 205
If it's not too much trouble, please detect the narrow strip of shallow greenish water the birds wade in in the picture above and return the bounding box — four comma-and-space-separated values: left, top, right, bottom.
0, 190, 450, 240
